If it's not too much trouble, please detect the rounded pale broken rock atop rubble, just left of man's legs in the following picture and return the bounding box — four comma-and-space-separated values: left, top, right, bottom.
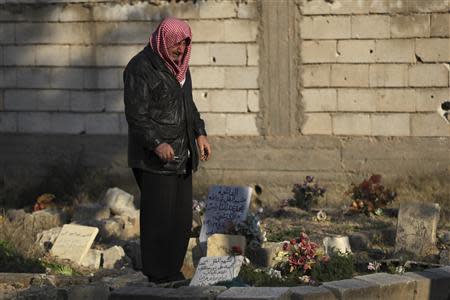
103, 187, 136, 216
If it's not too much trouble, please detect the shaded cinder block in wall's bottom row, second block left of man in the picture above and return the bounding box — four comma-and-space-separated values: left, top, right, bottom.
49, 113, 85, 134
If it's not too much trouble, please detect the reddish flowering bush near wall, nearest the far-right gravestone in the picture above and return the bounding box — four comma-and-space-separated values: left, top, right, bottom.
346, 174, 397, 215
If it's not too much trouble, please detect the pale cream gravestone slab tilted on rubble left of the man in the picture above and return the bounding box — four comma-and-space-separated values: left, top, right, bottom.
50, 224, 98, 264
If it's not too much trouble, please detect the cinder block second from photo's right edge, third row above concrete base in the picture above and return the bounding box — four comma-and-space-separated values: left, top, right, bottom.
369, 64, 408, 87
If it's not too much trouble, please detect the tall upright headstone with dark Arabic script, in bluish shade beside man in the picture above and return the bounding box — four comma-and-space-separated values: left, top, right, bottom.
200, 185, 252, 243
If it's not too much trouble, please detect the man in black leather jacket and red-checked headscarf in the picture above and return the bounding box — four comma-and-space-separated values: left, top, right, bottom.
123, 18, 211, 283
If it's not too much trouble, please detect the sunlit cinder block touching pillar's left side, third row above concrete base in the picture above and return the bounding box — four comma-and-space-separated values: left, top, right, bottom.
225, 67, 259, 89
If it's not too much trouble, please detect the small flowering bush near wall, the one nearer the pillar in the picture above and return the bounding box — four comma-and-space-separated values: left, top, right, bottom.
283, 176, 326, 211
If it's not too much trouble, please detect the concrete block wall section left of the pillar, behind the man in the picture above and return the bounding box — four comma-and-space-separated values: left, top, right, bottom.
0, 0, 259, 135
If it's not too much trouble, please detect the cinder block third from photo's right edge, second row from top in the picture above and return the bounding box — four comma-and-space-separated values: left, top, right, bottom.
352, 15, 391, 39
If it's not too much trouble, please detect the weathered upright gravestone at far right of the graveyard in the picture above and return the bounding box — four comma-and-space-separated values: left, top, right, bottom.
395, 203, 440, 257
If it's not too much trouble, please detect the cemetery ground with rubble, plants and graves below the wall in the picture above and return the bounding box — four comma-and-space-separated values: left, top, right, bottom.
0, 159, 450, 299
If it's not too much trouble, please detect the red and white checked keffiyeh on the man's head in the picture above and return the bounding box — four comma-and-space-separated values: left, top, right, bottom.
150, 18, 192, 82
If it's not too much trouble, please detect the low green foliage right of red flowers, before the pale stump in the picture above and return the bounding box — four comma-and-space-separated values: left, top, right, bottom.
311, 252, 355, 282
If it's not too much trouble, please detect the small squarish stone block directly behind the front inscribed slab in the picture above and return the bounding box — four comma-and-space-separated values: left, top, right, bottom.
206, 233, 246, 256
